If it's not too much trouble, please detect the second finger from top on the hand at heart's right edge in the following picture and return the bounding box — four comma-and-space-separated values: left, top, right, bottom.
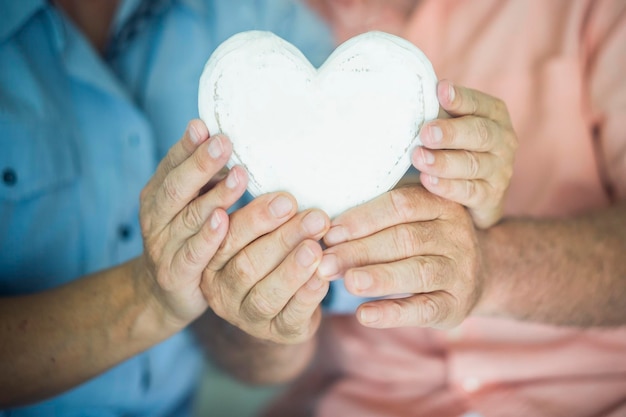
420, 116, 505, 152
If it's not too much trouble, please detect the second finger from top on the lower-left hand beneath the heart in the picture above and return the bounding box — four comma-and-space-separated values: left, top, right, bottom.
212, 210, 330, 301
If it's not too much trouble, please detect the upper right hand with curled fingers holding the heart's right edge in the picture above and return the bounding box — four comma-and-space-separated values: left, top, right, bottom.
412, 81, 518, 228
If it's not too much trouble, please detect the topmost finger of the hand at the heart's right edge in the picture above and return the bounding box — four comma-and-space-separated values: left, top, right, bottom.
437, 80, 510, 122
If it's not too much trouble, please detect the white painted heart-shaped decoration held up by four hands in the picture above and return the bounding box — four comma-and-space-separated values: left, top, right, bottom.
198, 31, 439, 217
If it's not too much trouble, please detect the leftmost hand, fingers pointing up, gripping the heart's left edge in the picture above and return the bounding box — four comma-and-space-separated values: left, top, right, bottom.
138, 120, 247, 327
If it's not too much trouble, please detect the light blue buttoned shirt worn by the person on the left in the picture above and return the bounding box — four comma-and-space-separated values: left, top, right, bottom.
0, 0, 333, 417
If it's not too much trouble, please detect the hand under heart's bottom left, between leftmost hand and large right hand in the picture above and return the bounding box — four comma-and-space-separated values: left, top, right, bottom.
201, 193, 330, 344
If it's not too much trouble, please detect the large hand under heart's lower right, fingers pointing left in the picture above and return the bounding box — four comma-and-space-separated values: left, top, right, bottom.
318, 185, 483, 328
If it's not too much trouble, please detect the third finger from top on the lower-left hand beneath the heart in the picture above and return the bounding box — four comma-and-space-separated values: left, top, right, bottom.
240, 240, 322, 323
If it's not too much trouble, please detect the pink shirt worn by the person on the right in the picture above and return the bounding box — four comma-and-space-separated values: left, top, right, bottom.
266, 0, 626, 417
